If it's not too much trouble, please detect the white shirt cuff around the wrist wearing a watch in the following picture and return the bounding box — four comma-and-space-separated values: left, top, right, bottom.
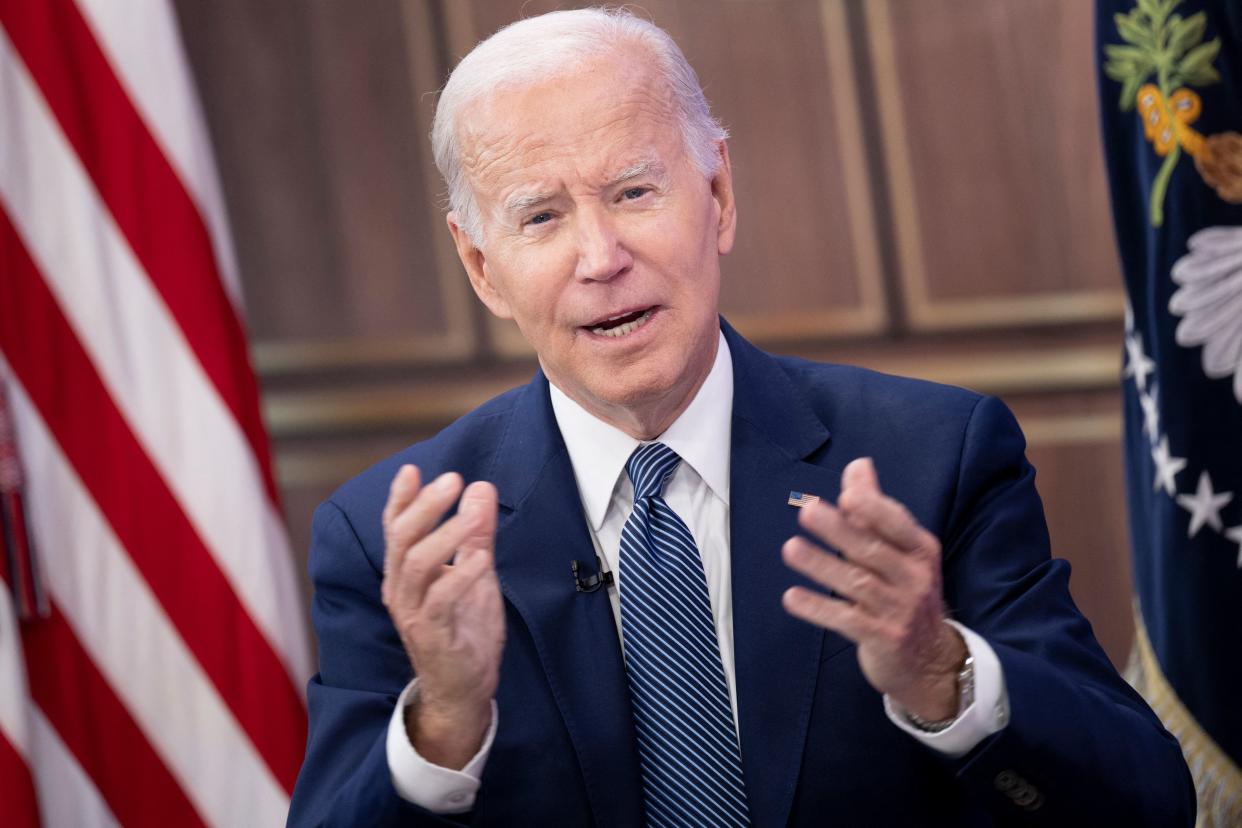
884, 621, 1009, 758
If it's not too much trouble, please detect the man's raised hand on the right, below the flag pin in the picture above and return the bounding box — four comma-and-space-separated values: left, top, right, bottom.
781, 458, 966, 721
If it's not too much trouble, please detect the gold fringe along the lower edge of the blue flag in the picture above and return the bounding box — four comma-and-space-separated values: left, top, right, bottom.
1125, 605, 1242, 828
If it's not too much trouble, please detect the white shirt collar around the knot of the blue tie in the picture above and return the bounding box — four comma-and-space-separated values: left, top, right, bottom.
549, 334, 733, 531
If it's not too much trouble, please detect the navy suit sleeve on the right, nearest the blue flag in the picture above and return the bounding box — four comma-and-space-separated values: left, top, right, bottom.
944, 398, 1195, 826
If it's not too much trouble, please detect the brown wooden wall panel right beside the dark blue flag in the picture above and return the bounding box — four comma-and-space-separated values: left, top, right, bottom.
864, 0, 1123, 329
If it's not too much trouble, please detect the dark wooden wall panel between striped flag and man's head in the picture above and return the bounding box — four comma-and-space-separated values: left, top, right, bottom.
179, 0, 476, 371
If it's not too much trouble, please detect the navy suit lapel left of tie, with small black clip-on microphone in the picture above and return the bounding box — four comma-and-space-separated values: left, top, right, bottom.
491, 374, 642, 826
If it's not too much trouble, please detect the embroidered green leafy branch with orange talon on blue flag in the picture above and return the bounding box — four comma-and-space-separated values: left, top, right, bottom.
1104, 0, 1242, 227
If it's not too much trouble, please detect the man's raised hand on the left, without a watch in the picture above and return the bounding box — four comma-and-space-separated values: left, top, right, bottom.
381, 466, 504, 768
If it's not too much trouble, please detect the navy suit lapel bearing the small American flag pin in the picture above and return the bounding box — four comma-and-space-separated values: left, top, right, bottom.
724, 325, 847, 826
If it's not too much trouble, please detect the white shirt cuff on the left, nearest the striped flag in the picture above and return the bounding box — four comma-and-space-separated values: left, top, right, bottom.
385, 679, 498, 813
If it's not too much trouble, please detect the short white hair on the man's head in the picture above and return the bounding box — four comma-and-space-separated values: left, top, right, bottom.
431, 9, 728, 245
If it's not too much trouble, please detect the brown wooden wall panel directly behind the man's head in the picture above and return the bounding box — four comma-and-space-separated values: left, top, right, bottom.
448, 0, 887, 354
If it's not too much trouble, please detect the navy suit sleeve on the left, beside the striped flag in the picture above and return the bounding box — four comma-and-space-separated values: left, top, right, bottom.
288, 500, 469, 828
